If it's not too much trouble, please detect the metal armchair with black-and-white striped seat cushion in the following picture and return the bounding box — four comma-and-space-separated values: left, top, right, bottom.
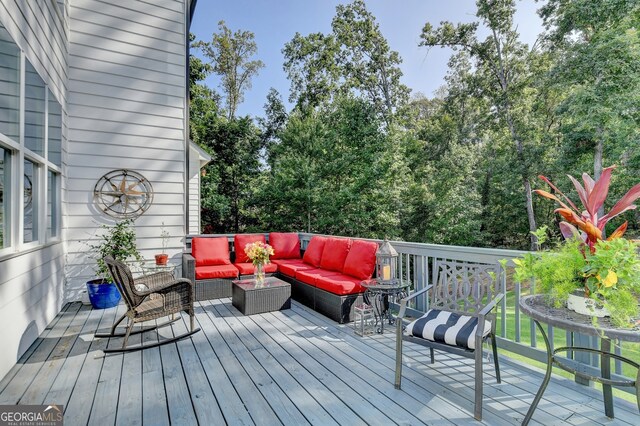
395, 260, 504, 420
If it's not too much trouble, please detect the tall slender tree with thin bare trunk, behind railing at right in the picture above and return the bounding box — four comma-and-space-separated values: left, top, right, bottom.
420, 0, 548, 249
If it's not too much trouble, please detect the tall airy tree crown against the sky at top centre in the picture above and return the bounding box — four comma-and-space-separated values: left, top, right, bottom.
283, 0, 409, 125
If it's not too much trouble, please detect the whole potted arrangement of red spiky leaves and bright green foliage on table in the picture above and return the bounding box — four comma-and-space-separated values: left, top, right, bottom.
514, 167, 640, 327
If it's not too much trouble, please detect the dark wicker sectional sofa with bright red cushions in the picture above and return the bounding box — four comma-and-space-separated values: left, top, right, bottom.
182, 232, 378, 323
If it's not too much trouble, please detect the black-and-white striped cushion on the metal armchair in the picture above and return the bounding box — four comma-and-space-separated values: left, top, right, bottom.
407, 309, 491, 349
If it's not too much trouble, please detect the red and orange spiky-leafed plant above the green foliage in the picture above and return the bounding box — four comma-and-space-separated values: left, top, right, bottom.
534, 166, 640, 253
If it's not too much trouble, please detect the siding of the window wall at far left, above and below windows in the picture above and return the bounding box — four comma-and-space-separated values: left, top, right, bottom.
0, 0, 68, 377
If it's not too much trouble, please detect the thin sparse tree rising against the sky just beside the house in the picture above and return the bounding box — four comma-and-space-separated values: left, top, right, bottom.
197, 21, 264, 120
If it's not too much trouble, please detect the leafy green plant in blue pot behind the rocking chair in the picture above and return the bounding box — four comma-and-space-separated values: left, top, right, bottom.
87, 219, 142, 309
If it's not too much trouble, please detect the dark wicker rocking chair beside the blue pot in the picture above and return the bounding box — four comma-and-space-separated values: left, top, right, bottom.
95, 256, 200, 353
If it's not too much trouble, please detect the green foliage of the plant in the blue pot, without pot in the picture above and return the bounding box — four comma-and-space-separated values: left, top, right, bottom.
90, 219, 143, 281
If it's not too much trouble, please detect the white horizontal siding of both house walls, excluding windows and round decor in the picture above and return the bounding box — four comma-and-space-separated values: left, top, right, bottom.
0, 0, 199, 378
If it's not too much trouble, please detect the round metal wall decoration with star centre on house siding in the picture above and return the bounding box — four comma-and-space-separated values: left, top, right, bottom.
93, 169, 153, 219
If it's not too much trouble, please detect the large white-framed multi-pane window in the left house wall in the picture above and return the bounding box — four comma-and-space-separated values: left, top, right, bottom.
0, 20, 63, 255
